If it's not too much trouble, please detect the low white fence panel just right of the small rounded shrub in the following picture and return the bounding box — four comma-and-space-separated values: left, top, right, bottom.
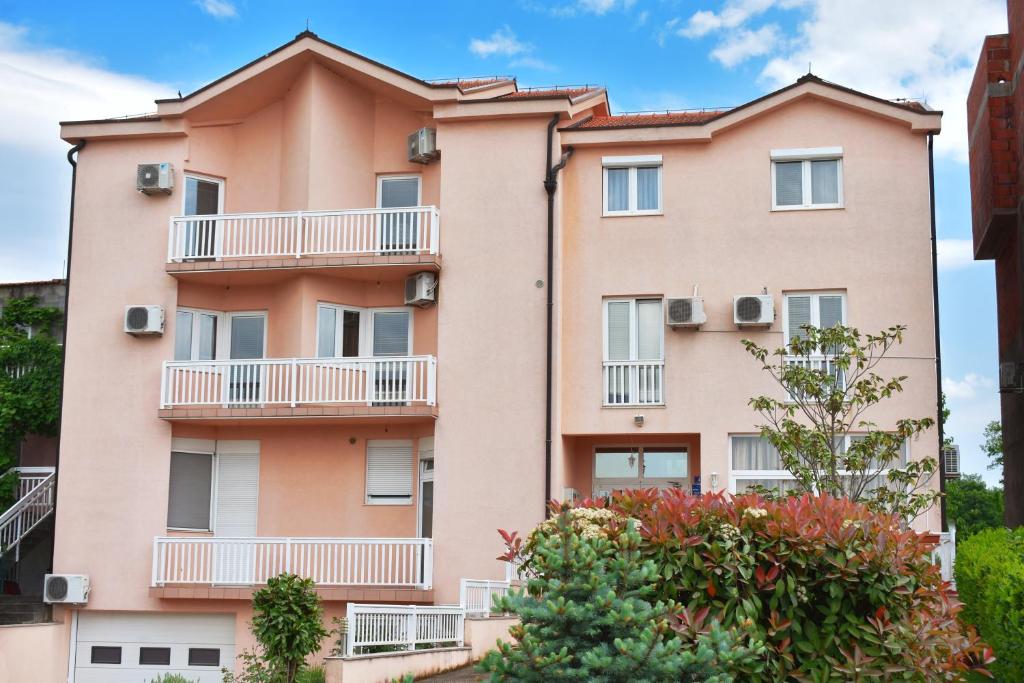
345, 602, 466, 656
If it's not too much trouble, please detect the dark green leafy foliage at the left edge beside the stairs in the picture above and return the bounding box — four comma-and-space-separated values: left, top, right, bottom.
0, 298, 60, 509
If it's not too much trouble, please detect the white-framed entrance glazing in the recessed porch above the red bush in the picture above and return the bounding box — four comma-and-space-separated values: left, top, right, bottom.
594, 446, 689, 496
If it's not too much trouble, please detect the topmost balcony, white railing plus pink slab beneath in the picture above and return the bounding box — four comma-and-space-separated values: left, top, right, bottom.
167, 206, 440, 282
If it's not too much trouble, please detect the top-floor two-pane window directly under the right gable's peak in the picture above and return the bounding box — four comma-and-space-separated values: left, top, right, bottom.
771, 147, 843, 211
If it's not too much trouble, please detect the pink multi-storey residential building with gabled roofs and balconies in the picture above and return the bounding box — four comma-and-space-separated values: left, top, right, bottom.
9, 33, 941, 683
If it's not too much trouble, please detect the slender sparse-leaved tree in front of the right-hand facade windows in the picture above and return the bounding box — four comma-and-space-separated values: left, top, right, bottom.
742, 325, 938, 523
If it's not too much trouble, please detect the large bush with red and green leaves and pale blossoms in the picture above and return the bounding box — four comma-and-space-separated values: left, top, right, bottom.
512, 489, 992, 681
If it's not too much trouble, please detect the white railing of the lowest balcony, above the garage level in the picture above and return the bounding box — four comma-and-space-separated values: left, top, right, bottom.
153, 537, 433, 590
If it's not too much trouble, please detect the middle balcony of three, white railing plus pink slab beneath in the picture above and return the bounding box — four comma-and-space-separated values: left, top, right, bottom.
160, 355, 437, 421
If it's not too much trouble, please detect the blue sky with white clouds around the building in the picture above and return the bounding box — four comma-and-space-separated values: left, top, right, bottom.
0, 0, 1006, 482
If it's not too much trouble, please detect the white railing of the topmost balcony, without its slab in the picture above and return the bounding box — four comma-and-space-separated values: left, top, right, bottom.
167, 206, 440, 262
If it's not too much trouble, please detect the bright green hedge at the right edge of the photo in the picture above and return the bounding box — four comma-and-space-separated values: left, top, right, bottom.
953, 527, 1024, 681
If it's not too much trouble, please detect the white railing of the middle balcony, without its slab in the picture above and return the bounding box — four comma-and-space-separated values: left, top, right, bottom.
160, 355, 437, 408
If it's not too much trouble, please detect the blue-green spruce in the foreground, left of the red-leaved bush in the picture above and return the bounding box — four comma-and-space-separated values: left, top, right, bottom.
479, 510, 760, 683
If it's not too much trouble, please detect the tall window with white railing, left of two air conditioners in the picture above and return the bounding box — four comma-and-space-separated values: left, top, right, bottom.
604, 299, 665, 405
